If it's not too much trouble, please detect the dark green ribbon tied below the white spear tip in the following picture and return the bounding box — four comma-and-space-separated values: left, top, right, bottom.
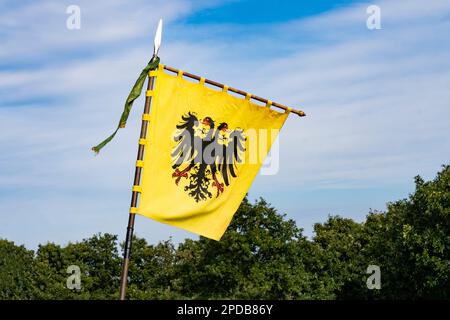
92, 57, 159, 153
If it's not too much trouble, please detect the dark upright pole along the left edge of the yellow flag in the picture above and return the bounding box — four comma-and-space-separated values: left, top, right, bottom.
119, 77, 155, 300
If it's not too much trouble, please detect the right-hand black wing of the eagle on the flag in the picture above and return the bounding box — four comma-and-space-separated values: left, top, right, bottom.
217, 129, 246, 186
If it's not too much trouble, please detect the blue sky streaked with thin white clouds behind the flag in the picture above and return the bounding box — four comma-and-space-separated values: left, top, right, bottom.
0, 0, 450, 249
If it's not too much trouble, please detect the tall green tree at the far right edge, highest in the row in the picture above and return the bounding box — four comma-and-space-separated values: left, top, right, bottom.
366, 166, 450, 299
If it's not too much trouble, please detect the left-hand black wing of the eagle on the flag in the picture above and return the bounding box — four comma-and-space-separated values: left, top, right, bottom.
171, 112, 199, 169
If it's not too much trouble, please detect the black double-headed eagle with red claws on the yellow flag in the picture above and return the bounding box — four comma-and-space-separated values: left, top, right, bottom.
171, 112, 246, 202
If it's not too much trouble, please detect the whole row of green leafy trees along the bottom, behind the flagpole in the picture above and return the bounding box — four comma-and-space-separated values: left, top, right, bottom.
0, 166, 450, 299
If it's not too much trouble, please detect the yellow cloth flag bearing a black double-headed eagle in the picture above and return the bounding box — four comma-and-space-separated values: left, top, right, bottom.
131, 65, 289, 240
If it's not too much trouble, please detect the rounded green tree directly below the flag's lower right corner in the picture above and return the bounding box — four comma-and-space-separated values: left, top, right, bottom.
176, 199, 331, 299
